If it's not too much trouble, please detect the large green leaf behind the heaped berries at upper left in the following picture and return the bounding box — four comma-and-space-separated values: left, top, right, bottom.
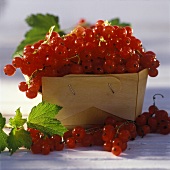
13, 14, 65, 57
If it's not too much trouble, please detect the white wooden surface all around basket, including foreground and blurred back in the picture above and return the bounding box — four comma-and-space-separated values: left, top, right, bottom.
0, 0, 170, 170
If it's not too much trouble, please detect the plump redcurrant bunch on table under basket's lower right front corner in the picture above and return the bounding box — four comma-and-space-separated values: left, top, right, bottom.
102, 117, 137, 156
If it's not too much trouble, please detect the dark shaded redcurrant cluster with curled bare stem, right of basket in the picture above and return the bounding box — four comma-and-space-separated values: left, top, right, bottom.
135, 94, 170, 137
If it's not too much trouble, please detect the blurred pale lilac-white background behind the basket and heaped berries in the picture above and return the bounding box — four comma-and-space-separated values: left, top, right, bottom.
0, 0, 170, 115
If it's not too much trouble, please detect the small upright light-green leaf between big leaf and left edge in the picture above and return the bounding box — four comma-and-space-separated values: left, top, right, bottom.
9, 108, 27, 128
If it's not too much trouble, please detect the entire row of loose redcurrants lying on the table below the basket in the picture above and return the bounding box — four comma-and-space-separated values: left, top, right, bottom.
28, 94, 170, 156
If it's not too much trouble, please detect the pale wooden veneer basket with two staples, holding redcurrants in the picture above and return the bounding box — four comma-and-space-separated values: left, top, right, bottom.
42, 69, 148, 128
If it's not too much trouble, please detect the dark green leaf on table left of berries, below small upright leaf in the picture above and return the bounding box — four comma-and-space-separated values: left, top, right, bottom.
7, 128, 32, 155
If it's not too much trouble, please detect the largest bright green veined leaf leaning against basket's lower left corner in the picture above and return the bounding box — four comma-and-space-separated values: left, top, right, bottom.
27, 102, 67, 136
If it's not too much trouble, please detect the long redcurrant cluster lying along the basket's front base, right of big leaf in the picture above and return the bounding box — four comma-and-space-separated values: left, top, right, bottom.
64, 117, 137, 156
